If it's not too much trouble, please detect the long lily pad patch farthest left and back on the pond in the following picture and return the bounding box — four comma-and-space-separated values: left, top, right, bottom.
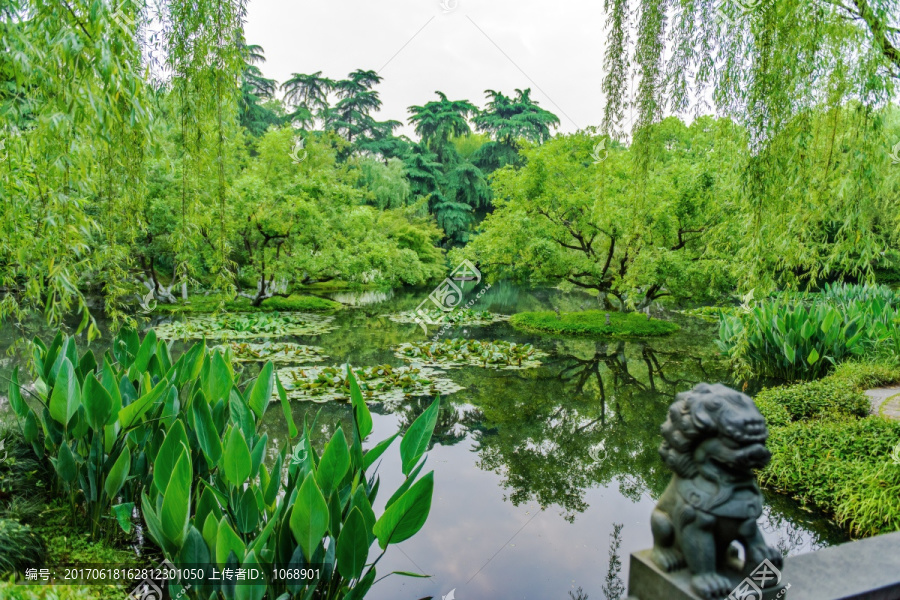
155, 312, 334, 340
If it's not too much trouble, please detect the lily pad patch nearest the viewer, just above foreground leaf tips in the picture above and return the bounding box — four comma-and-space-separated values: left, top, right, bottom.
278, 365, 462, 402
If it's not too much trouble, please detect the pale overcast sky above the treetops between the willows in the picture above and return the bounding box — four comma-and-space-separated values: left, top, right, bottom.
246, 0, 605, 135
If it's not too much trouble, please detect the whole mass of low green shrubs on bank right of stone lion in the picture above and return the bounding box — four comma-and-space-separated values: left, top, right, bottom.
755, 362, 900, 536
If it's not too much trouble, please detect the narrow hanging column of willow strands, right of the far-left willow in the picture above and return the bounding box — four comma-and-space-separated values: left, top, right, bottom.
151, 0, 247, 301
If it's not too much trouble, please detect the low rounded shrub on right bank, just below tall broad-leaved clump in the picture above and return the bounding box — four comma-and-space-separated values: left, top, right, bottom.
755, 377, 870, 421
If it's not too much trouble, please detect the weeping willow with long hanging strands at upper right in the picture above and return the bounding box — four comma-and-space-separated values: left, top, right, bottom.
603, 0, 900, 289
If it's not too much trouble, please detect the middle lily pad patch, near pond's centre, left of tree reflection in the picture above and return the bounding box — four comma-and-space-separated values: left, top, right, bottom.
394, 338, 547, 369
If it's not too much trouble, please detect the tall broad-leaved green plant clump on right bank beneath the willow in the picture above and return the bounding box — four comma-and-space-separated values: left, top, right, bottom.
716, 286, 897, 380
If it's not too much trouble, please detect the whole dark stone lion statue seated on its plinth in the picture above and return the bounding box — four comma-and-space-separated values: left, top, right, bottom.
650, 383, 782, 599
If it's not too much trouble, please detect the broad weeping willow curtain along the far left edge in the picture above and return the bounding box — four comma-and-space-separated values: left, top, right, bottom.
0, 0, 150, 333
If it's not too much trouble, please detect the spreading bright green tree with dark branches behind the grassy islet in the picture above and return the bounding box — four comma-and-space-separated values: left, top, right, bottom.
461, 118, 737, 310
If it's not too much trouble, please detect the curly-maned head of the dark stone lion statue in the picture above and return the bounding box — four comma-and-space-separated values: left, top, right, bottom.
659, 383, 771, 480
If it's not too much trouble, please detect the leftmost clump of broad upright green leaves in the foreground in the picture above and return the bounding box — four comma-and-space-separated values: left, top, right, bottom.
9, 330, 185, 536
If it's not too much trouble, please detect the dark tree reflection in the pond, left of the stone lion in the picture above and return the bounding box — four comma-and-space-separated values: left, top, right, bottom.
474, 341, 722, 522
